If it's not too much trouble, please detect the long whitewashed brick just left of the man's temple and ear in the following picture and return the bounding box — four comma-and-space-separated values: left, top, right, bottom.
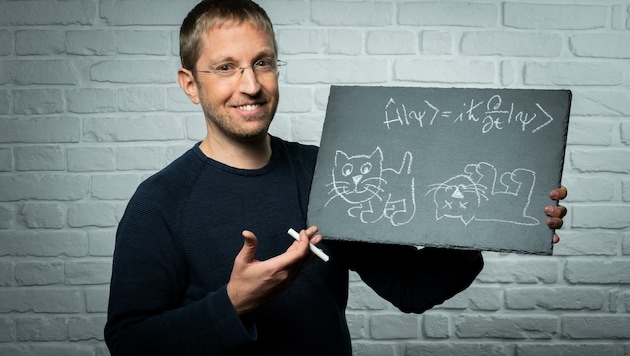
90, 59, 179, 84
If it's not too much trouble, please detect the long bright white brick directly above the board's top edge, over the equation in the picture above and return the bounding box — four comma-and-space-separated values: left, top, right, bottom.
394, 59, 495, 84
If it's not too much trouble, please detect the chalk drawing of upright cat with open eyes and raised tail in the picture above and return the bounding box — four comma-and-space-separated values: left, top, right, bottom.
325, 147, 416, 226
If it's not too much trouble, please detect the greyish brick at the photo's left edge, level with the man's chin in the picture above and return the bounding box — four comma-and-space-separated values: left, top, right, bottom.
0, 117, 80, 143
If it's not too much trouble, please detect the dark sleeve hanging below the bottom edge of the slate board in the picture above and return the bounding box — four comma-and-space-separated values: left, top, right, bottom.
329, 241, 483, 313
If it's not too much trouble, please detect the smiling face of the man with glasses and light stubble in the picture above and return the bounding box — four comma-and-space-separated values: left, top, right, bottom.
196, 23, 279, 140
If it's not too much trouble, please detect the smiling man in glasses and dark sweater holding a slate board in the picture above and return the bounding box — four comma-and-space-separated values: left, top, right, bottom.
105, 0, 566, 355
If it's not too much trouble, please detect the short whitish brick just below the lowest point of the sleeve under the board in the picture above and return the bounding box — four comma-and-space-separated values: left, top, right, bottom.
370, 313, 420, 340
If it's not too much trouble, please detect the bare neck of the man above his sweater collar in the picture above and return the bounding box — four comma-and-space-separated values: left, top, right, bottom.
199, 135, 271, 169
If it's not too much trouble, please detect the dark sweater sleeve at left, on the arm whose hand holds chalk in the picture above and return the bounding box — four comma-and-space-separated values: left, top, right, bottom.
105, 177, 256, 355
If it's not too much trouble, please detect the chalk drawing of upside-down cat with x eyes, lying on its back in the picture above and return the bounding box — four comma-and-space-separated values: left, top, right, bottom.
425, 162, 540, 226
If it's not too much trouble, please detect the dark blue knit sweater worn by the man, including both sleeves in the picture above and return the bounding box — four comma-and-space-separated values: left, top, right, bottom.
105, 138, 483, 356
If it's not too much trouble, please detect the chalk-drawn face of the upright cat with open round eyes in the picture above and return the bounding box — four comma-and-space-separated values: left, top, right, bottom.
332, 147, 383, 204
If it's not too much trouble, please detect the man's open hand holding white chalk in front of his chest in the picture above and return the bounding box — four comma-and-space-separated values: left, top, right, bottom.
227, 226, 322, 315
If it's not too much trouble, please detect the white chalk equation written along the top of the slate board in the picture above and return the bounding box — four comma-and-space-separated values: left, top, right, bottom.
383, 94, 554, 134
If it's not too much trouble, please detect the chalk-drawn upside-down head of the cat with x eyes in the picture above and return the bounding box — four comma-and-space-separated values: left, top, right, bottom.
429, 175, 485, 225
